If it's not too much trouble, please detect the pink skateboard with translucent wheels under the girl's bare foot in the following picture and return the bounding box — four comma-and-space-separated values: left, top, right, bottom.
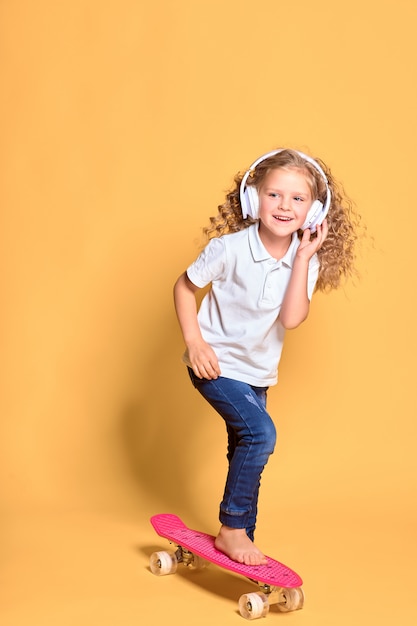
150, 513, 304, 619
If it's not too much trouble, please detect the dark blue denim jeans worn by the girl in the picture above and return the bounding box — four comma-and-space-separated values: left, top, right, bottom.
188, 368, 276, 541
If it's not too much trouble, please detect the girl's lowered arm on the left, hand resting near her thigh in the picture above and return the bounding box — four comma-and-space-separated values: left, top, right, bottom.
174, 272, 221, 380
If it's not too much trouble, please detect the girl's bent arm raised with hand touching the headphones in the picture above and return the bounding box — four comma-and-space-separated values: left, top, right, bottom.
279, 220, 328, 330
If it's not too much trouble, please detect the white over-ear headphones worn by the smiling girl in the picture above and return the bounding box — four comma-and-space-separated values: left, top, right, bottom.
239, 148, 332, 233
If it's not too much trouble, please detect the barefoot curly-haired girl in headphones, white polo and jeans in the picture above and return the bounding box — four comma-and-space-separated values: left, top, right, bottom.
174, 149, 358, 565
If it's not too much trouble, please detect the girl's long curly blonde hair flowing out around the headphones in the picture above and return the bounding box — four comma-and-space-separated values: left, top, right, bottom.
203, 149, 361, 291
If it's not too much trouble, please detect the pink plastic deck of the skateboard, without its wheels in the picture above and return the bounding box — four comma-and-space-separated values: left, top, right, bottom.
151, 513, 303, 588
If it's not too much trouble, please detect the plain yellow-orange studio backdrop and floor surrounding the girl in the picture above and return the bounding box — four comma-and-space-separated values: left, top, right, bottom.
0, 0, 417, 626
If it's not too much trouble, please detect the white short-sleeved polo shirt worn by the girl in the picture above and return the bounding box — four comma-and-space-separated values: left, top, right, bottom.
183, 223, 319, 387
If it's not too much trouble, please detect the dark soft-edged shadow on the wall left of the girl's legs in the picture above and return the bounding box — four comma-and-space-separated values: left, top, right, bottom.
115, 314, 217, 519
